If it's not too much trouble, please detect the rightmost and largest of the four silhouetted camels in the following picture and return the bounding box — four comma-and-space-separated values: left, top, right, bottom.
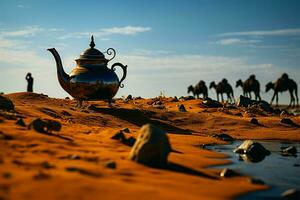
266, 73, 299, 107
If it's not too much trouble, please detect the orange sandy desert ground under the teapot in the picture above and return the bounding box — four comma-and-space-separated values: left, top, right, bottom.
0, 92, 300, 200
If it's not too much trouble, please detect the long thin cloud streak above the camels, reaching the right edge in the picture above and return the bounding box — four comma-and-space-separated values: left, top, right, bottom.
218, 28, 300, 37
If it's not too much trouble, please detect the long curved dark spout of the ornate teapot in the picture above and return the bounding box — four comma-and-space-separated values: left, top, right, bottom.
47, 48, 70, 94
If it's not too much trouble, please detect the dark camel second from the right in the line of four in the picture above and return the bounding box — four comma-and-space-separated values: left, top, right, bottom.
235, 74, 261, 100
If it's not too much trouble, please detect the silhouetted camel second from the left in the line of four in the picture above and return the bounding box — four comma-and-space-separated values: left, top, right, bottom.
209, 78, 235, 103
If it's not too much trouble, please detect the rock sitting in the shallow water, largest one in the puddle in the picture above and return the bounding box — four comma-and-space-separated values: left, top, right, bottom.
234, 140, 270, 162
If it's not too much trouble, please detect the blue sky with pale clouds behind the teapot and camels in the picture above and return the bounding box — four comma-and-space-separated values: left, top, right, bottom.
0, 0, 300, 103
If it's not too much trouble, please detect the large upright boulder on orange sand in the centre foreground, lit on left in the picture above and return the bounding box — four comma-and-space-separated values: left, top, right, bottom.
129, 124, 171, 167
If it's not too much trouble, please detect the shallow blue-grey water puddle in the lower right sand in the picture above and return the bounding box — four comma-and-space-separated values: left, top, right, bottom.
207, 141, 300, 200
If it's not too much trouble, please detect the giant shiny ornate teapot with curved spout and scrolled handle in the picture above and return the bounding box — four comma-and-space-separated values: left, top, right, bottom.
47, 36, 127, 104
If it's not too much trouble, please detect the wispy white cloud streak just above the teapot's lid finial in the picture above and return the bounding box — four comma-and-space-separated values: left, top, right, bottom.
60, 26, 151, 39
